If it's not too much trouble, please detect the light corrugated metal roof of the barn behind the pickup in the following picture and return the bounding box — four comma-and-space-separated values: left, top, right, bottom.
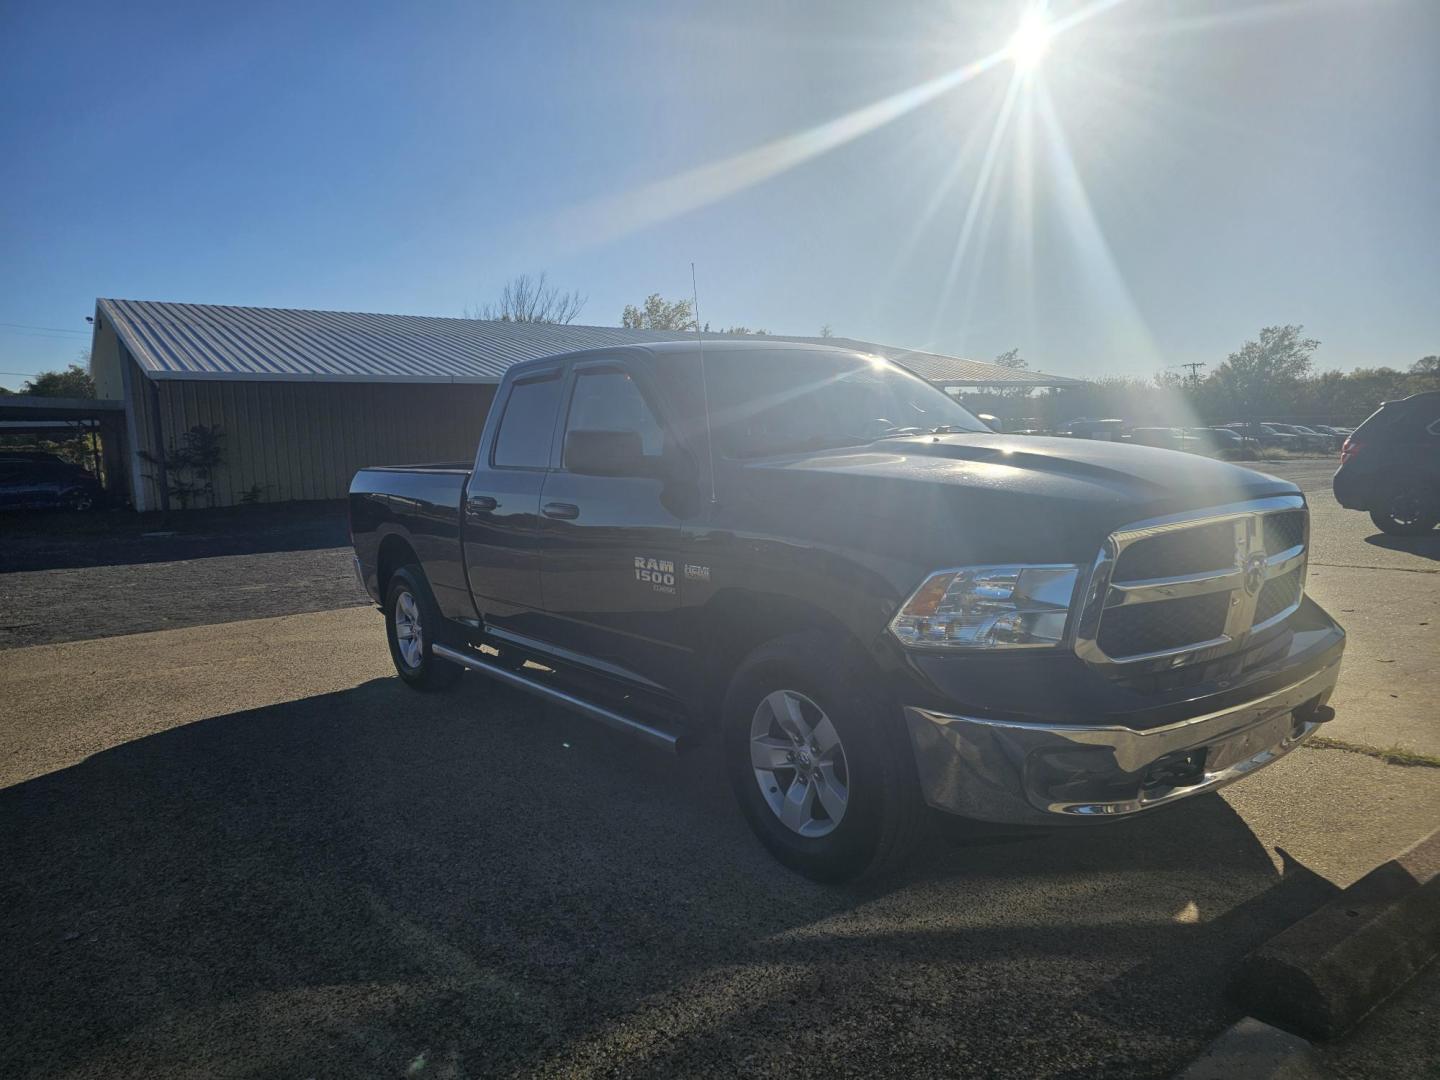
96, 300, 1081, 386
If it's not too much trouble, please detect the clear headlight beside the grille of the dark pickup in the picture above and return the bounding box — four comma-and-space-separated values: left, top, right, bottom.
890, 566, 1080, 649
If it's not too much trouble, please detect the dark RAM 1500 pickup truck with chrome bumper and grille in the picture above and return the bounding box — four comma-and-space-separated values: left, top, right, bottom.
350, 341, 1345, 880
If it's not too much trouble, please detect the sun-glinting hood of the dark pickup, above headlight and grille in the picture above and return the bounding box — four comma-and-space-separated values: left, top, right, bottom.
746, 433, 1299, 562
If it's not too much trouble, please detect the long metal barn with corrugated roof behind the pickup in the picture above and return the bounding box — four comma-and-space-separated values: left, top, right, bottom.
91, 300, 1080, 510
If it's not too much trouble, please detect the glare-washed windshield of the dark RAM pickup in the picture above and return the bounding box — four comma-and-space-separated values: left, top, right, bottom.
706, 350, 989, 458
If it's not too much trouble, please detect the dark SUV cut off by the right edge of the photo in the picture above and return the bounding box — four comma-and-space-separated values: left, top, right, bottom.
1332, 390, 1440, 536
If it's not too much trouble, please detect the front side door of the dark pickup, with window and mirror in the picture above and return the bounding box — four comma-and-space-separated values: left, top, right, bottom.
540, 359, 688, 693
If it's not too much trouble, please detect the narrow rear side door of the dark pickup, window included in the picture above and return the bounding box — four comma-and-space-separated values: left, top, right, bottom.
462, 364, 563, 632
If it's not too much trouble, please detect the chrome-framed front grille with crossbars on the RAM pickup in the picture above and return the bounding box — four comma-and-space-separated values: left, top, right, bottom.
1076, 495, 1309, 670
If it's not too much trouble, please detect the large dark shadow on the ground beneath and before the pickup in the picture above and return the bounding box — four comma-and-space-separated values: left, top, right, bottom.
0, 678, 1333, 1076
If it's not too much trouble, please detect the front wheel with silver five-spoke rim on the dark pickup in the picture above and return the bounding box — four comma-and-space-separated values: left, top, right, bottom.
721, 634, 926, 883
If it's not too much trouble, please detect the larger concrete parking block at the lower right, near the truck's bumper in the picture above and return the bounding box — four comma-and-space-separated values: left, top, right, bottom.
1231, 829, 1440, 1040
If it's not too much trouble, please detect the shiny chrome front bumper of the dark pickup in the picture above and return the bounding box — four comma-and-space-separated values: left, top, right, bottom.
904, 654, 1341, 825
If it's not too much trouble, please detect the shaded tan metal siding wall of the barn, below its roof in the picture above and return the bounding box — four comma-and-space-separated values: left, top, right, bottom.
132, 372, 495, 508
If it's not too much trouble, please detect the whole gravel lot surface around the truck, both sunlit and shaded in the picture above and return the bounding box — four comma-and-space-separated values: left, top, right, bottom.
0, 462, 1440, 1077
